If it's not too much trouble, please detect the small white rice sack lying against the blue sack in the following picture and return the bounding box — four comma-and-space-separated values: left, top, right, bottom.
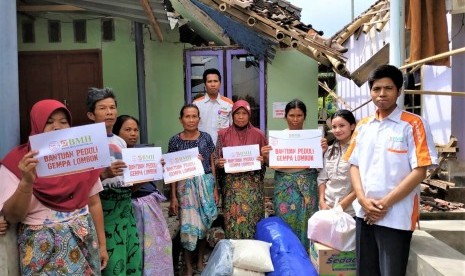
231, 240, 274, 272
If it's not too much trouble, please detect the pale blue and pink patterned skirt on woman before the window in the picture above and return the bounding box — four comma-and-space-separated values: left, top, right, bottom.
177, 173, 218, 251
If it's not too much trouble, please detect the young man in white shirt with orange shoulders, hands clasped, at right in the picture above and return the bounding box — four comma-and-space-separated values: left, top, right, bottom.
345, 65, 437, 276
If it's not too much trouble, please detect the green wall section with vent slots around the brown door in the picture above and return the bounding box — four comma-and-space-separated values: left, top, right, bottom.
18, 14, 138, 122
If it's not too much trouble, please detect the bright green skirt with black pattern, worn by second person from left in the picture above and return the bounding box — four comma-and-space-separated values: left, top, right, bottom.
100, 188, 142, 275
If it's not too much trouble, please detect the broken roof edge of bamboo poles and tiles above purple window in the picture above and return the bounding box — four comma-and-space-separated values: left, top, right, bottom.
199, 0, 350, 77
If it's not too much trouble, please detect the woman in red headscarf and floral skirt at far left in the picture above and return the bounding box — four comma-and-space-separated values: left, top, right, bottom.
0, 100, 108, 275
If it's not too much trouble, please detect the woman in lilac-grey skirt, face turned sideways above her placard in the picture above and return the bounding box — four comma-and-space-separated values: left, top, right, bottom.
113, 115, 174, 276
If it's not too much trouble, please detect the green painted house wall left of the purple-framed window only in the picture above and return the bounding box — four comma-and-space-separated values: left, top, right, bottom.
18, 15, 190, 150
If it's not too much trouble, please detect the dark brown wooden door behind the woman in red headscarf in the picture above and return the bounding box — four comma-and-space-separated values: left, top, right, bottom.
19, 50, 102, 143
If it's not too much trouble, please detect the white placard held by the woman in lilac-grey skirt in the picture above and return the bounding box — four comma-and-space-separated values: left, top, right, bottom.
121, 147, 163, 184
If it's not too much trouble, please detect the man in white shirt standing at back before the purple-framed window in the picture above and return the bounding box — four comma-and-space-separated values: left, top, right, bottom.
193, 68, 233, 145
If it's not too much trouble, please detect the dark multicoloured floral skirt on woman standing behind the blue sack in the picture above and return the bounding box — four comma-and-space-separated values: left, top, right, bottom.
273, 169, 318, 250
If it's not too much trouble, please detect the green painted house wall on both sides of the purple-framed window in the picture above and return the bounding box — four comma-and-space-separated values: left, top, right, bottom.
18, 16, 318, 151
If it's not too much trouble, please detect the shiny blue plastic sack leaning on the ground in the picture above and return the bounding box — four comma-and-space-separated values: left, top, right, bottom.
255, 217, 318, 276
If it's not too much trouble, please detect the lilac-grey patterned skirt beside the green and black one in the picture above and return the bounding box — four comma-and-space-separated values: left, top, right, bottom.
132, 192, 174, 276
